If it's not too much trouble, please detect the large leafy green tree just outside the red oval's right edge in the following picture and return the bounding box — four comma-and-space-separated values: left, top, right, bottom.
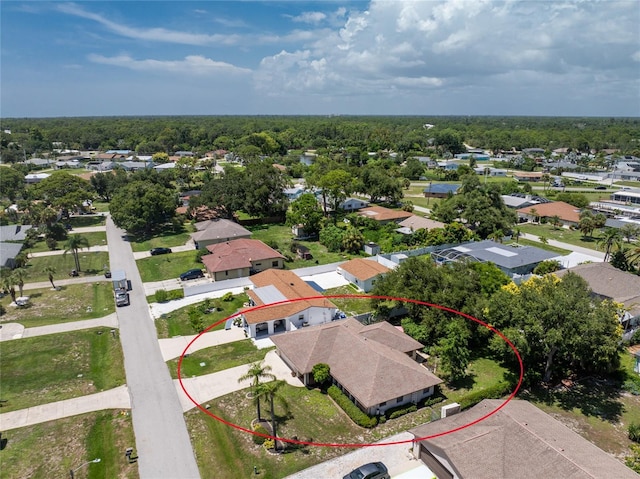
484, 273, 622, 383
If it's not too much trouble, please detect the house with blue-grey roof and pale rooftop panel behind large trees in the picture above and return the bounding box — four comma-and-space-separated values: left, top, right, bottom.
431, 240, 557, 277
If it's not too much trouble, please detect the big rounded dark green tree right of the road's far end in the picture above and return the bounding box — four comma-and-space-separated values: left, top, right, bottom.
109, 181, 177, 234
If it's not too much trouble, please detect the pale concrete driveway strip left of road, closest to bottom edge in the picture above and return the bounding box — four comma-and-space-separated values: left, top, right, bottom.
0, 385, 131, 431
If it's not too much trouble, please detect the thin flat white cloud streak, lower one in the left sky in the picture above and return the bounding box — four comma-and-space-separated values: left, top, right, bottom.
88, 54, 251, 75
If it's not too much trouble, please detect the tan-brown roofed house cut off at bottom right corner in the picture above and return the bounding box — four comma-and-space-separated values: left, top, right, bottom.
410, 399, 638, 479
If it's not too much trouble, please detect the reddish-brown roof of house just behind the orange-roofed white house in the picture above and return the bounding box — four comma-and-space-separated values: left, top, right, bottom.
202, 238, 284, 272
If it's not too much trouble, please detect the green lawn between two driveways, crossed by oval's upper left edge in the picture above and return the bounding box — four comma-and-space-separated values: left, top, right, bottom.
167, 339, 273, 379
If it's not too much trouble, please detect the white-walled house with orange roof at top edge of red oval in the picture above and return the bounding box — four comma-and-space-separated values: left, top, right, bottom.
241, 268, 338, 338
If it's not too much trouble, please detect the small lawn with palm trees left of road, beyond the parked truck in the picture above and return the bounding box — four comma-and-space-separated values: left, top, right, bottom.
26, 250, 109, 283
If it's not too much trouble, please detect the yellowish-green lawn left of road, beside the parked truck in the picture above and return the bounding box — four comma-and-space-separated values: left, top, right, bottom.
0, 282, 115, 328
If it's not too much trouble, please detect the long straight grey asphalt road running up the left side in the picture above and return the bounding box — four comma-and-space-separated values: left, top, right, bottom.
107, 217, 200, 479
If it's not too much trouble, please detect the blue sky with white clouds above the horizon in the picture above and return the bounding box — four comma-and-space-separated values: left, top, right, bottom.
0, 0, 640, 117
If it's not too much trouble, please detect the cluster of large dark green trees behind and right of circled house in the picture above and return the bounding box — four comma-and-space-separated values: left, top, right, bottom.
373, 258, 622, 384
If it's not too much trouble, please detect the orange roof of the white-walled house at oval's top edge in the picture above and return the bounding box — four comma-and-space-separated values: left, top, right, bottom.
241, 270, 336, 324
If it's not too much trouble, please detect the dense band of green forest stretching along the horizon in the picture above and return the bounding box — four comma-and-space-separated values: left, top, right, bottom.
0, 116, 640, 162
